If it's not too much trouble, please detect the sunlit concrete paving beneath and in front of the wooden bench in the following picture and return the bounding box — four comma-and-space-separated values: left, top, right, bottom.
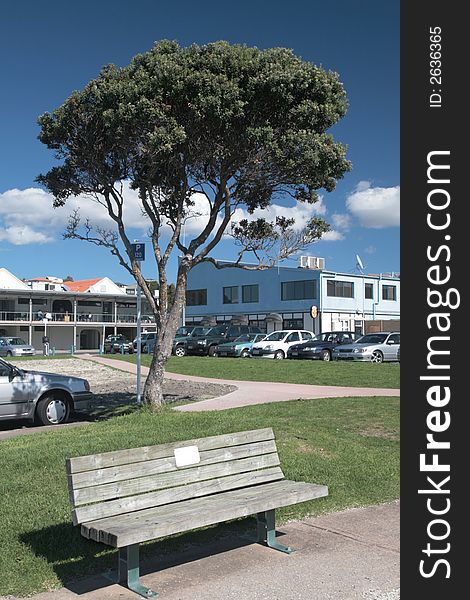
0, 502, 400, 600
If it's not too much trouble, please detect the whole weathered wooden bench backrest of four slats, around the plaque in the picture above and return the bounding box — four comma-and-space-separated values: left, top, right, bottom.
67, 428, 284, 524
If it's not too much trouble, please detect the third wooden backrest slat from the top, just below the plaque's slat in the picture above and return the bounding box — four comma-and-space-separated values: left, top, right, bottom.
71, 452, 280, 507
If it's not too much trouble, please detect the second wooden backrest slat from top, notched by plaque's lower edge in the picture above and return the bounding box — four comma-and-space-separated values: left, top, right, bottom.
69, 440, 276, 490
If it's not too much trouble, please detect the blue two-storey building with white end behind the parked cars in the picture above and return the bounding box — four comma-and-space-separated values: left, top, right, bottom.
184, 257, 400, 333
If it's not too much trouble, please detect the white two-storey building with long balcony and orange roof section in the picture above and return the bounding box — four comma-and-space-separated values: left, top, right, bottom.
0, 268, 155, 351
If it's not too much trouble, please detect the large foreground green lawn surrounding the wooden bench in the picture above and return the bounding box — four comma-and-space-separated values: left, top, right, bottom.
0, 396, 399, 595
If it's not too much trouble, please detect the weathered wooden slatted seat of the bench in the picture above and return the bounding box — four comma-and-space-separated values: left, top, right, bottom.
81, 480, 328, 547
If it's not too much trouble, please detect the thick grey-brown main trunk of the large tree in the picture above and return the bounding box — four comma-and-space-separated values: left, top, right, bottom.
143, 266, 186, 409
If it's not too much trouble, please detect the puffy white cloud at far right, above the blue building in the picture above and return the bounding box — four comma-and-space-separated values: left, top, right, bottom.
346, 181, 400, 229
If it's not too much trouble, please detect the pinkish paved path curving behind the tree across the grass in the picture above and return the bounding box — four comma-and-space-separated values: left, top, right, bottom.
80, 355, 400, 412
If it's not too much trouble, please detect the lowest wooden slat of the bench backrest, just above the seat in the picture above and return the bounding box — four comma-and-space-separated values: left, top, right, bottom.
72, 467, 284, 525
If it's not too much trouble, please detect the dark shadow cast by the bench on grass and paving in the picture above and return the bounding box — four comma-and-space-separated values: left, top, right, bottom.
20, 517, 284, 595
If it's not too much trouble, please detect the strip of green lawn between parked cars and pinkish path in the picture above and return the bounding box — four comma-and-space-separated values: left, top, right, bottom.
112, 354, 400, 388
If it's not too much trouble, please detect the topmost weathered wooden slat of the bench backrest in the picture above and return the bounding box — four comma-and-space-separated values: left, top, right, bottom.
66, 428, 274, 475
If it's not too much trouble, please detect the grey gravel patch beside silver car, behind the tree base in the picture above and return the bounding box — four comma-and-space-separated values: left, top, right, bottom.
16, 358, 236, 416
